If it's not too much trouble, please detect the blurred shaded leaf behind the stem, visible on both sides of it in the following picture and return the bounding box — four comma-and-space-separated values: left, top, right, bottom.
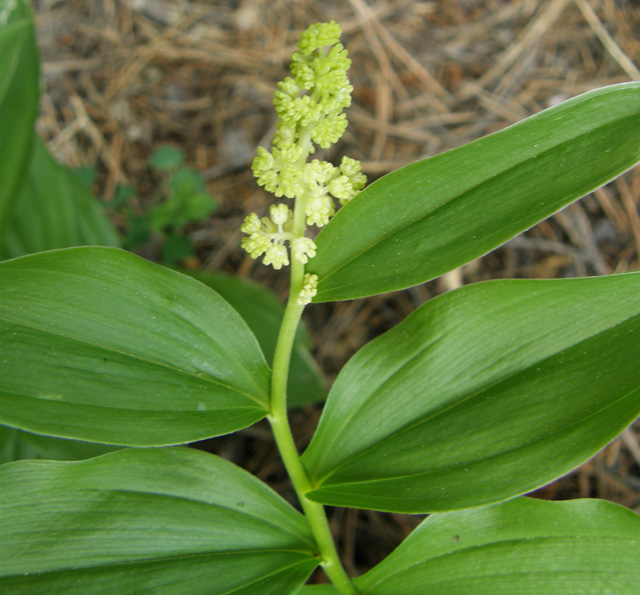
187, 272, 326, 407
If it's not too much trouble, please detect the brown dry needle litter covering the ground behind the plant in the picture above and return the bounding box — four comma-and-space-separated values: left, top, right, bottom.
36, 0, 640, 573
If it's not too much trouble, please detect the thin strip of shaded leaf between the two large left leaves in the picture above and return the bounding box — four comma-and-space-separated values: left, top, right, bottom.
0, 426, 121, 464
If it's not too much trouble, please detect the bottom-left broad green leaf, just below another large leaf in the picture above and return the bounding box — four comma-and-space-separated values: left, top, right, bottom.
0, 448, 318, 595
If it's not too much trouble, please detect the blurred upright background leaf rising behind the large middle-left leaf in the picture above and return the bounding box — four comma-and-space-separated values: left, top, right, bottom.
3, 137, 119, 258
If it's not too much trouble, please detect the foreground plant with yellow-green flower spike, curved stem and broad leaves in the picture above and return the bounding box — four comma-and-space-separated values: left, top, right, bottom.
0, 12, 640, 595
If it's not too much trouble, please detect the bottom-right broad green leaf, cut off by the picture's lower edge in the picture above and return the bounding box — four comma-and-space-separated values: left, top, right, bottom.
354, 498, 640, 595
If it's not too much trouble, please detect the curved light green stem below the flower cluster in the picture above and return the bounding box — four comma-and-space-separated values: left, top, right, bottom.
269, 272, 357, 595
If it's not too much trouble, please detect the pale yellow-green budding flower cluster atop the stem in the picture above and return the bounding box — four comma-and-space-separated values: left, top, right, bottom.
241, 21, 366, 301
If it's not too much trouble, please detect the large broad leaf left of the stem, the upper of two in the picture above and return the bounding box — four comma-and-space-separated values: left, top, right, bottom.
0, 247, 270, 446
